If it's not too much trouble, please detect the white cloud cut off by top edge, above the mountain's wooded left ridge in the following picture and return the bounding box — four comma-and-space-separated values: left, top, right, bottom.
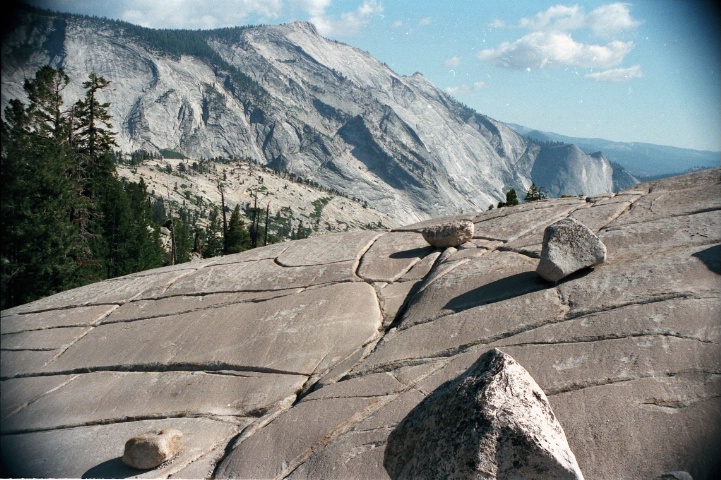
118, 0, 283, 29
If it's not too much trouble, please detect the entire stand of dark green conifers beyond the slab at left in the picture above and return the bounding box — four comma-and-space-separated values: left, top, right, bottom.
0, 66, 260, 309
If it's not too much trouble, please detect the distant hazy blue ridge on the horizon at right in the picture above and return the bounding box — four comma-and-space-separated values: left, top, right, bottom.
508, 123, 721, 178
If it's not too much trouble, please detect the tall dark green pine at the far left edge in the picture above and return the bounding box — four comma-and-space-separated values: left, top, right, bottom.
0, 67, 89, 308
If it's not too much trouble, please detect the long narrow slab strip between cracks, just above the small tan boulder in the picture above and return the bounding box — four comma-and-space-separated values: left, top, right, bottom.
1, 372, 308, 433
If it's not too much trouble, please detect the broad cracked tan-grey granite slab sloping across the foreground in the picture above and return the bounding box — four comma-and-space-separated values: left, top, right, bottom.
0, 169, 721, 479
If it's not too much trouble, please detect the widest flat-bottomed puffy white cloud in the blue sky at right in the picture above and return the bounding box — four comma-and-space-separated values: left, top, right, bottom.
478, 32, 634, 69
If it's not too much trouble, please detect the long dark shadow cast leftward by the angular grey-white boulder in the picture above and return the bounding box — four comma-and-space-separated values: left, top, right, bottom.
443, 272, 552, 312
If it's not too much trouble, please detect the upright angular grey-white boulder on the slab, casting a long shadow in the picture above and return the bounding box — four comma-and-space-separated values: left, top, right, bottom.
536, 218, 606, 282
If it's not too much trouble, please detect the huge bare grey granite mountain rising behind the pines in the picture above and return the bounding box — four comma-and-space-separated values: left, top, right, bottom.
2, 5, 612, 222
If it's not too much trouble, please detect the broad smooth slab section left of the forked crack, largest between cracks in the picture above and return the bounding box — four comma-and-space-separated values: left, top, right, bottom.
38, 282, 382, 375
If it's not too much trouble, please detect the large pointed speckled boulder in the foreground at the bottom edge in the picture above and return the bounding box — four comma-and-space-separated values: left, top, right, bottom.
384, 349, 583, 480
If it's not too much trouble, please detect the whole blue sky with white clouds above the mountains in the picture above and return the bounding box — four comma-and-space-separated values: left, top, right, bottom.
22, 0, 721, 151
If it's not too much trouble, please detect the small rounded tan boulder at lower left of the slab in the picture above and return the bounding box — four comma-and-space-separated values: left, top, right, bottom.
123, 428, 183, 470
